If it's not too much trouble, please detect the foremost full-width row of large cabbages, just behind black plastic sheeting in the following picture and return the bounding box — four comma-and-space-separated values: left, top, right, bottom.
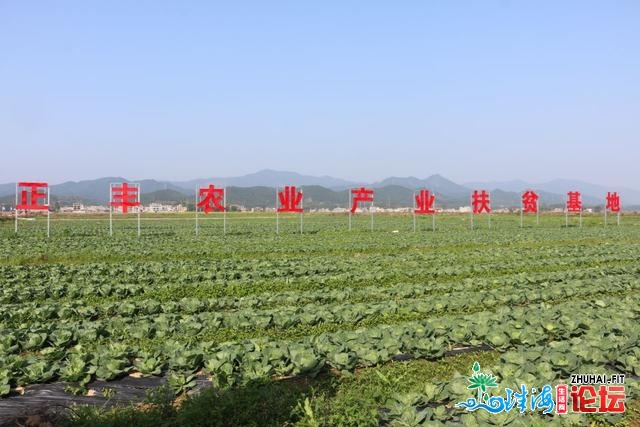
0, 296, 640, 398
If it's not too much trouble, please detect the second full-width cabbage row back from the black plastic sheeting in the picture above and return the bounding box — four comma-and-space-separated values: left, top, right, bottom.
0, 277, 640, 370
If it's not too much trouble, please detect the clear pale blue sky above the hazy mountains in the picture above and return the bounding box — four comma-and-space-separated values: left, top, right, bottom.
0, 0, 640, 188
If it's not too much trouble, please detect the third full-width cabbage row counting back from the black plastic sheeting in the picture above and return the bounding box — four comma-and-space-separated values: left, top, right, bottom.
0, 264, 640, 328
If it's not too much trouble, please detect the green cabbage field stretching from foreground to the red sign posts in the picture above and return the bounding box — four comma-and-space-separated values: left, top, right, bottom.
0, 213, 640, 426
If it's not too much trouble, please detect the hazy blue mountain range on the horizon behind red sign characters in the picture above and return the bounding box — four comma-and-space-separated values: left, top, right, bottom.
0, 169, 640, 208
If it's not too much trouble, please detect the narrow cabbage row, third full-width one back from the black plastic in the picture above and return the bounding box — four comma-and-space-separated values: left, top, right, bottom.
0, 265, 640, 329
